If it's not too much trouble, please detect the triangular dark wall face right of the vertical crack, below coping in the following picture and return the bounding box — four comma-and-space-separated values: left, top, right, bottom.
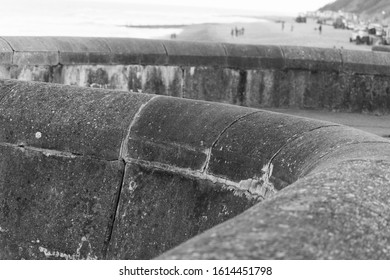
107, 162, 257, 259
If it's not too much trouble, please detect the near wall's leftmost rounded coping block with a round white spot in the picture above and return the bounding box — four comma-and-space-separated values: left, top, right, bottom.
0, 80, 151, 160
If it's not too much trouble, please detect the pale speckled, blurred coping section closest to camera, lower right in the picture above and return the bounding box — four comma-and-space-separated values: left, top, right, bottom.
159, 159, 390, 259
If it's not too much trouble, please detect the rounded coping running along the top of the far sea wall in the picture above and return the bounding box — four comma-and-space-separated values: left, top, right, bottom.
0, 36, 390, 75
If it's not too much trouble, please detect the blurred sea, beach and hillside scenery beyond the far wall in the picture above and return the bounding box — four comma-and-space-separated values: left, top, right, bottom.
0, 0, 390, 50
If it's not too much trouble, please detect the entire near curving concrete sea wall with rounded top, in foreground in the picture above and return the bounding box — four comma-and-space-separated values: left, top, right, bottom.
0, 80, 390, 259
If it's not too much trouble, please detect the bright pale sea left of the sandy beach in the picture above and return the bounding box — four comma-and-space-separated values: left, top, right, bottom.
0, 0, 266, 38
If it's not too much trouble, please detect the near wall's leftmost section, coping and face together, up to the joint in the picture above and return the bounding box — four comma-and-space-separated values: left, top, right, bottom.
0, 80, 153, 259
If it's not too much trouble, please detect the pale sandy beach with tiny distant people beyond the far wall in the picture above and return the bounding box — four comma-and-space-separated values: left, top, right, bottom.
164, 17, 372, 50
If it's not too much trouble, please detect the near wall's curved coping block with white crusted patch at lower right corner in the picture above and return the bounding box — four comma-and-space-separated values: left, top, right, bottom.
208, 111, 336, 186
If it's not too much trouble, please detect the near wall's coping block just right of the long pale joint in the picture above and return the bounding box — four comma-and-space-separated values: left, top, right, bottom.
124, 97, 255, 172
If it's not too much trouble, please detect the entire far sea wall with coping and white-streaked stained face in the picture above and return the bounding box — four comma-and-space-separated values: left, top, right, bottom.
0, 37, 390, 114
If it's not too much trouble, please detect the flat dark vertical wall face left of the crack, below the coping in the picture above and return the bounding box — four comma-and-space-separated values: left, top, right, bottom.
0, 144, 123, 259
